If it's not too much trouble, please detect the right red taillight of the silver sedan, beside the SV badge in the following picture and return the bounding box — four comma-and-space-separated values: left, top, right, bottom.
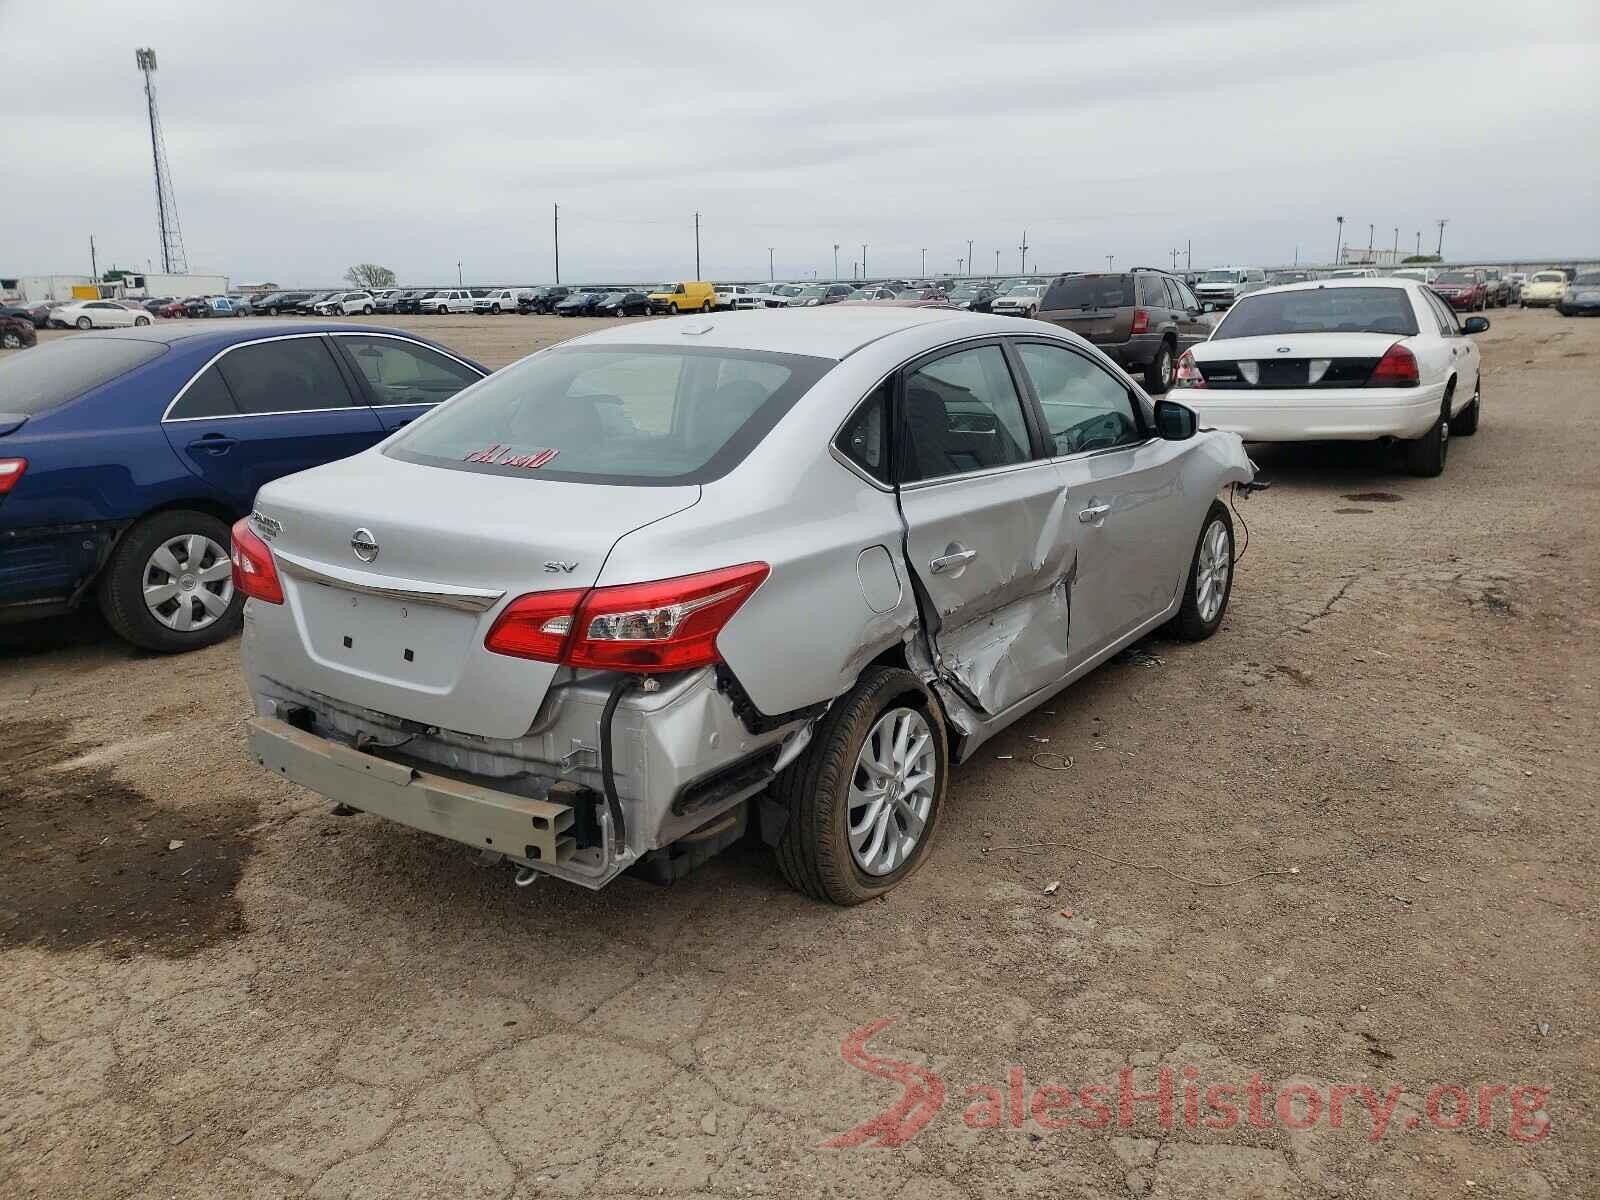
483, 563, 771, 674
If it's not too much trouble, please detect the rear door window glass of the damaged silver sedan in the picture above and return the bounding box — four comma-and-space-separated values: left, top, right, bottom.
902, 346, 1032, 482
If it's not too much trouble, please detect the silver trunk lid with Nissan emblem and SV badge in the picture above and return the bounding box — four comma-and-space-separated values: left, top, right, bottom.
254, 453, 699, 738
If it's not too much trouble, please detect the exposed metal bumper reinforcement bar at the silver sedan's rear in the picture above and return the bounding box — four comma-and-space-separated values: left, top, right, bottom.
248, 717, 578, 874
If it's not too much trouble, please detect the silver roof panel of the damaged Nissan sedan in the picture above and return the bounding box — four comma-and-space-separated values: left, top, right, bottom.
566, 304, 1004, 358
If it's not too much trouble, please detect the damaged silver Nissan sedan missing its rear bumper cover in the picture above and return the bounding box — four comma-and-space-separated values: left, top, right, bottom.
243, 306, 1253, 904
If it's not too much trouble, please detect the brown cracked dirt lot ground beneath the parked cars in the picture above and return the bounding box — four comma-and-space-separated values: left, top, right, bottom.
0, 312, 1600, 1200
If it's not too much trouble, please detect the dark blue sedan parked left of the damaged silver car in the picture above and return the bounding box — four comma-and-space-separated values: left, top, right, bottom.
0, 322, 488, 653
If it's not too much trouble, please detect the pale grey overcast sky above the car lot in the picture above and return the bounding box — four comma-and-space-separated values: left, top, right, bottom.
0, 0, 1600, 285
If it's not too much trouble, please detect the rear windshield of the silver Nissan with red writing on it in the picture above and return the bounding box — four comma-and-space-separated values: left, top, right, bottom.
384, 346, 834, 485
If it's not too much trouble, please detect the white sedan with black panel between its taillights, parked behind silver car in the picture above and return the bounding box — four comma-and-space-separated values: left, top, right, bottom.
1174, 278, 1490, 475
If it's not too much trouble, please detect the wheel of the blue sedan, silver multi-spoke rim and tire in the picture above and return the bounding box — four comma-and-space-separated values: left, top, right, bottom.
99, 509, 245, 654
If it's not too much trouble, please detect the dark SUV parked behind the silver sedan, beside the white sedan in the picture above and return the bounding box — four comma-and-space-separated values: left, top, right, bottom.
1034, 267, 1211, 395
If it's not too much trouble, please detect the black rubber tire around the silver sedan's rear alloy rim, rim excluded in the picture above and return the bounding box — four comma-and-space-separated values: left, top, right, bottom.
773, 667, 950, 906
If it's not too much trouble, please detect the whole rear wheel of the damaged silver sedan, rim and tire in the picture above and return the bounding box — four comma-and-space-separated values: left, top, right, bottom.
773, 667, 949, 904
